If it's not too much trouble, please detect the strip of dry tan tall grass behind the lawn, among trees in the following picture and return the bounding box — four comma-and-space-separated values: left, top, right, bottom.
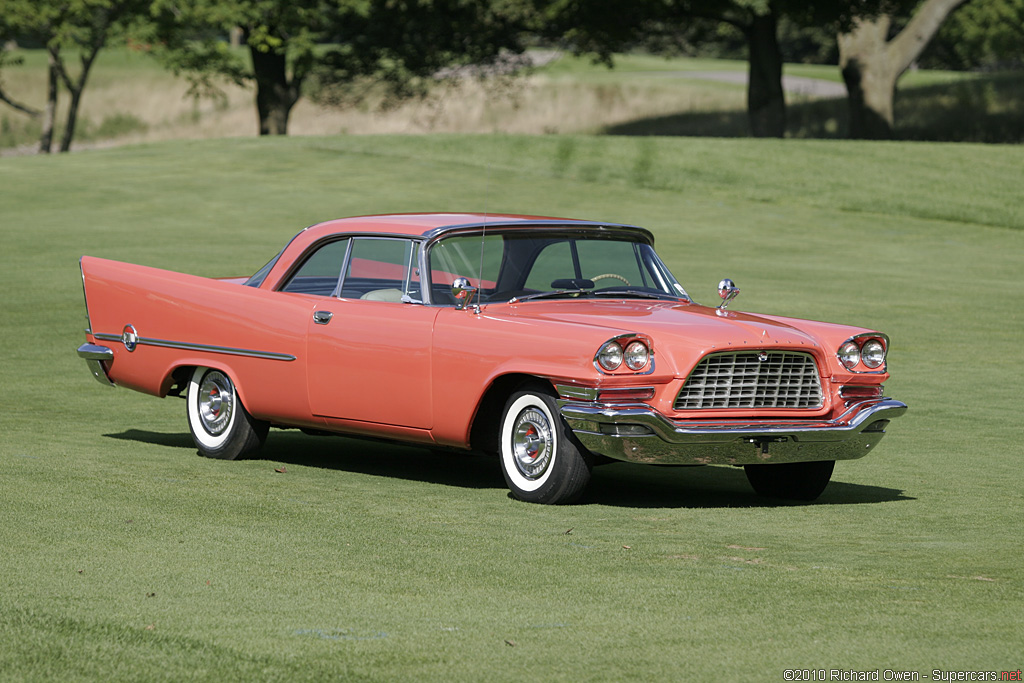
0, 50, 744, 152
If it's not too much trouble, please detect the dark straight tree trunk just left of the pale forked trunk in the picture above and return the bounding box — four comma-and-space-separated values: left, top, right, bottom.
746, 11, 785, 137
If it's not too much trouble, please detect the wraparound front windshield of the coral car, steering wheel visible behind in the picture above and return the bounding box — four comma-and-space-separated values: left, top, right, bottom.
429, 230, 688, 304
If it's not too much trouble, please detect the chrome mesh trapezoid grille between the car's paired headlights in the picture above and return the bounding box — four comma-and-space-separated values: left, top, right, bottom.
675, 351, 821, 411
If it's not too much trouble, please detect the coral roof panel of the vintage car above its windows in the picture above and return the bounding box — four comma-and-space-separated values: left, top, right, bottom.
303, 213, 649, 242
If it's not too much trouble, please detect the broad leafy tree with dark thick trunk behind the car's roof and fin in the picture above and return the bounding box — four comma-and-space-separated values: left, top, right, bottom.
154, 0, 527, 135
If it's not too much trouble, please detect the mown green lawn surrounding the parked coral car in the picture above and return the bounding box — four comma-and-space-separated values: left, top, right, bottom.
0, 135, 1024, 681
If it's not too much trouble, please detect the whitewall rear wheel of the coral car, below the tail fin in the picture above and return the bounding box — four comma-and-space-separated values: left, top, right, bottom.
185, 368, 270, 460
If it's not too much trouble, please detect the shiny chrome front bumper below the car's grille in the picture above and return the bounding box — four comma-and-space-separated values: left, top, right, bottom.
558, 394, 906, 465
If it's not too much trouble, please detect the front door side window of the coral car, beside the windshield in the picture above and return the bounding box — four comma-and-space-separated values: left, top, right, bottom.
341, 238, 423, 302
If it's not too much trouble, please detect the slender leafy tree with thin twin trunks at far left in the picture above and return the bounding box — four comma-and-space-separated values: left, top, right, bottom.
0, 0, 147, 154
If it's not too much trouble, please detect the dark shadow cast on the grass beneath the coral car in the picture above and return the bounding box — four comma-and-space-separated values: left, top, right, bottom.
104, 429, 914, 508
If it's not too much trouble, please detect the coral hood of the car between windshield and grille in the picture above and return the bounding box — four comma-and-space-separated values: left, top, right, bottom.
487, 300, 820, 374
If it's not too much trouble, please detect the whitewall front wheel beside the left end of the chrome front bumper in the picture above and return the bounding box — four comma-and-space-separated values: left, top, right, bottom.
499, 386, 591, 505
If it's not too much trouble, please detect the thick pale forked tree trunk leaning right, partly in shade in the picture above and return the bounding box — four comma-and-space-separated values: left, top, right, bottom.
839, 0, 966, 139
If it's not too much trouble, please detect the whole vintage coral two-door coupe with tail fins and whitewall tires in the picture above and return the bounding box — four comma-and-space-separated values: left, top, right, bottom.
78, 214, 906, 503
